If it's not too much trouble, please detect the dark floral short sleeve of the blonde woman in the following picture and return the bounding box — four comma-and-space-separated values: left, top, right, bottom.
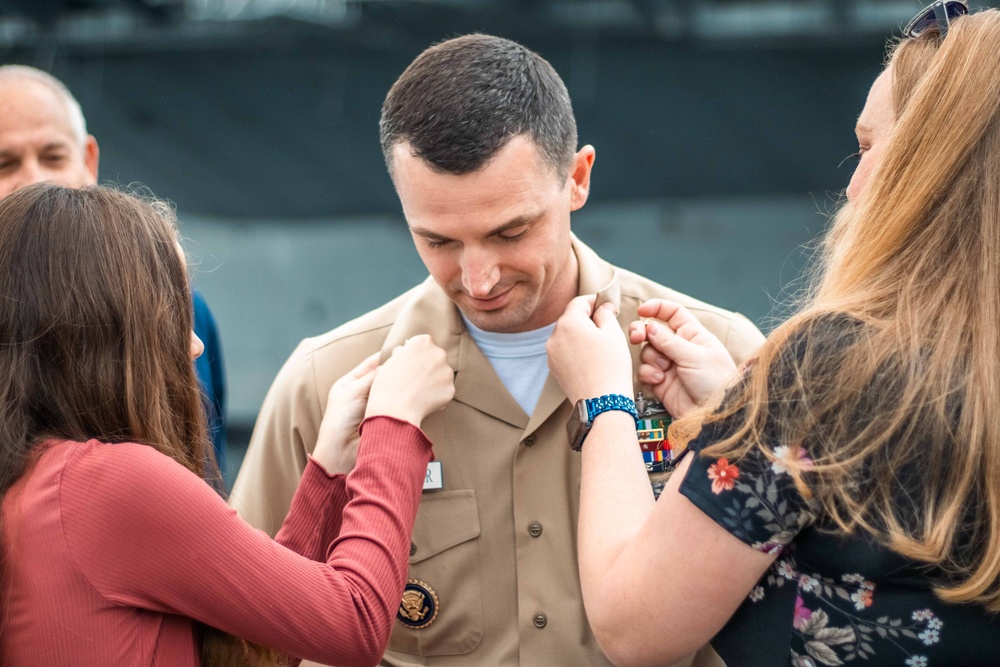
680, 422, 816, 554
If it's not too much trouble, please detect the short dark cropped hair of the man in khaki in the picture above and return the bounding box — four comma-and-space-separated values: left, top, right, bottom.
379, 35, 576, 175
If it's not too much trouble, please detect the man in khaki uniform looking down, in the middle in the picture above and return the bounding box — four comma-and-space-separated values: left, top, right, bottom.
232, 35, 763, 667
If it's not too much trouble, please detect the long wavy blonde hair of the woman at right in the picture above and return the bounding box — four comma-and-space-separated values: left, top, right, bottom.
671, 10, 1000, 611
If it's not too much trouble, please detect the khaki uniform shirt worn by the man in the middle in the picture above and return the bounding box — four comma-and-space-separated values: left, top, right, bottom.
231, 239, 763, 667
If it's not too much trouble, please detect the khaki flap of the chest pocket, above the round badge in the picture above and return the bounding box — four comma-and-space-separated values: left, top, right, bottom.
410, 489, 479, 563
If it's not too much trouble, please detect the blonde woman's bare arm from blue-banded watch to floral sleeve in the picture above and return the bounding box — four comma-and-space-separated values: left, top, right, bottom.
578, 428, 774, 666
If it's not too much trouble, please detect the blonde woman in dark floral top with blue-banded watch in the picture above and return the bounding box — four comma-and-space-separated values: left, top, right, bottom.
549, 0, 1000, 667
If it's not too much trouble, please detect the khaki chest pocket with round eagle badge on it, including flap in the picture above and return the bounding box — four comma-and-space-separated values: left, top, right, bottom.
389, 489, 483, 656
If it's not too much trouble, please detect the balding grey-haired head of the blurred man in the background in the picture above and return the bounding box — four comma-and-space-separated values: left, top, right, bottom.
0, 65, 98, 197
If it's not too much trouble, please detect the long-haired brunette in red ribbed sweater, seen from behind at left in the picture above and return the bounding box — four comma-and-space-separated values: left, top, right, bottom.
0, 184, 454, 667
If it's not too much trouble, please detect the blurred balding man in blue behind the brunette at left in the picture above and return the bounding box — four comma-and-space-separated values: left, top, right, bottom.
0, 65, 226, 484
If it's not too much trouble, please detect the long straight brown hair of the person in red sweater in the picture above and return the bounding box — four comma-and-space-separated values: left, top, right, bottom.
0, 183, 274, 665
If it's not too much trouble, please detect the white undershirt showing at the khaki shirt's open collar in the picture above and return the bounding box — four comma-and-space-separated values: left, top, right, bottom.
462, 315, 556, 415
